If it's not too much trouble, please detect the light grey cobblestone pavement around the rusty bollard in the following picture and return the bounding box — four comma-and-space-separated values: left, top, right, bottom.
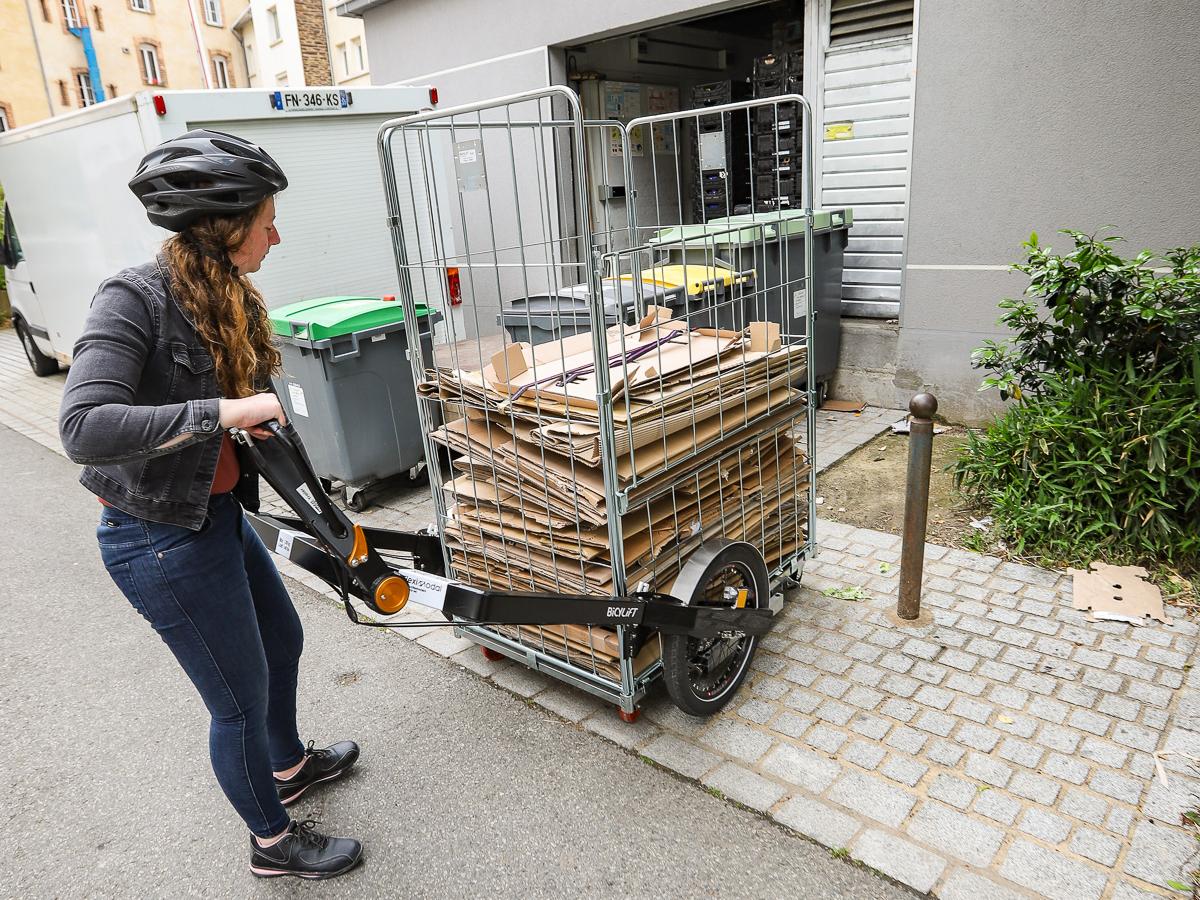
0, 331, 1200, 900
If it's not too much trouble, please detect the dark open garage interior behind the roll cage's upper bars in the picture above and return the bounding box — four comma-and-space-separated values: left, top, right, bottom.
557, 0, 804, 236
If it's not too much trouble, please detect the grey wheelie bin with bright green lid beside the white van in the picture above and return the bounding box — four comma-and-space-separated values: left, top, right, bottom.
270, 296, 442, 510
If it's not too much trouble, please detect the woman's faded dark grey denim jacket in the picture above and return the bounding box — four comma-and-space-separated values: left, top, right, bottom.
59, 258, 258, 530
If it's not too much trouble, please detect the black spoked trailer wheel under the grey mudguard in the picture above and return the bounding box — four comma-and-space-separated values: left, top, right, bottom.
662, 539, 770, 715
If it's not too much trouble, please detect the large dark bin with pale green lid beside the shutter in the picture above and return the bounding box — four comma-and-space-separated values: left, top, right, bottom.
649, 209, 854, 384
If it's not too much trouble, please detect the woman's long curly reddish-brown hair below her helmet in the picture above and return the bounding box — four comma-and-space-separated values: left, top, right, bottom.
163, 206, 282, 397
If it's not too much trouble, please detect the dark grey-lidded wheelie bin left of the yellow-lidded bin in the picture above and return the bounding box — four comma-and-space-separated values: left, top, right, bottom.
496, 277, 683, 344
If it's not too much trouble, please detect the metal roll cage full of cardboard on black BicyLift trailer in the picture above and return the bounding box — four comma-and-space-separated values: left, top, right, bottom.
248, 86, 816, 720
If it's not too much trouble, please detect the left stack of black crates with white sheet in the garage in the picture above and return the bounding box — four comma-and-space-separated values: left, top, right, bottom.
691, 82, 751, 222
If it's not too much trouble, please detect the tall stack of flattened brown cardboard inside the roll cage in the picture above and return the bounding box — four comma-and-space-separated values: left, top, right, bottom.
419, 307, 809, 679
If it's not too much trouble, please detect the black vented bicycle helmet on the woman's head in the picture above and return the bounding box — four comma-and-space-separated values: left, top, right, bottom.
130, 128, 288, 232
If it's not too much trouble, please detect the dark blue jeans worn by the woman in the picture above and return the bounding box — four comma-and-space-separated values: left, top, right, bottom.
96, 494, 304, 838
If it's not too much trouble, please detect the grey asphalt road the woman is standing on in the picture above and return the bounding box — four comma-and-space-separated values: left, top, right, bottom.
0, 426, 912, 898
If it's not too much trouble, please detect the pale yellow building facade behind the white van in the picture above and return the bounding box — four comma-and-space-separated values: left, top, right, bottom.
0, 0, 246, 126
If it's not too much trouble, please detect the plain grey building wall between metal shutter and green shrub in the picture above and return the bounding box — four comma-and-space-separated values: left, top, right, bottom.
894, 0, 1200, 419
